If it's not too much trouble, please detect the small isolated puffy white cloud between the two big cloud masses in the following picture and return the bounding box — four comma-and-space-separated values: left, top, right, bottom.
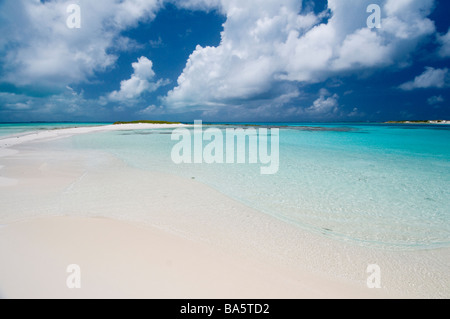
108, 56, 169, 101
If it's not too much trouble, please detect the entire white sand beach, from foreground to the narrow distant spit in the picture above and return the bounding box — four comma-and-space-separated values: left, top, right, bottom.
0, 125, 450, 298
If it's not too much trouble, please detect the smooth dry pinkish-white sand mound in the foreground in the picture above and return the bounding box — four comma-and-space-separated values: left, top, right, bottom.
0, 217, 382, 299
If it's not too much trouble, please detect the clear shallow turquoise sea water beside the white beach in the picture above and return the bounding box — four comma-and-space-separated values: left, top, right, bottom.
0, 123, 450, 250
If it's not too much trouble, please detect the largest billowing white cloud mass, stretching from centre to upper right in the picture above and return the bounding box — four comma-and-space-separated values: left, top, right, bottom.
164, 0, 435, 109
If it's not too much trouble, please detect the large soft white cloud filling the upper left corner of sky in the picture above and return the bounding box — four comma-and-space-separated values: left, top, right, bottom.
0, 0, 161, 90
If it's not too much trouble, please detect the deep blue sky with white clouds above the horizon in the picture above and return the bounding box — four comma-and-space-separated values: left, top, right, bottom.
0, 0, 450, 122
